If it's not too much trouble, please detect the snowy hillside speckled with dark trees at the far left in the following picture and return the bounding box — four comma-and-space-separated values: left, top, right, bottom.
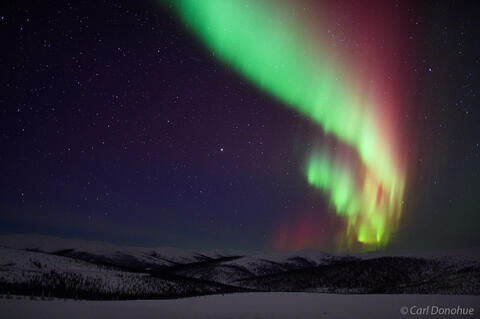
0, 247, 188, 297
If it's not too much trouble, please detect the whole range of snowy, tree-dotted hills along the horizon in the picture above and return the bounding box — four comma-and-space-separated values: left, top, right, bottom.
0, 235, 480, 299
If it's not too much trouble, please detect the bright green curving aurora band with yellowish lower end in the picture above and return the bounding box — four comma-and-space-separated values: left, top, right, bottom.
165, 0, 405, 250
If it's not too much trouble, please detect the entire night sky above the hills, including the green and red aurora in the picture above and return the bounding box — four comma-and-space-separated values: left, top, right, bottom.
0, 0, 480, 253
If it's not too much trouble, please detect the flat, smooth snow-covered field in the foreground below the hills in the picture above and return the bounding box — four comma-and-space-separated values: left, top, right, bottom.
0, 293, 480, 319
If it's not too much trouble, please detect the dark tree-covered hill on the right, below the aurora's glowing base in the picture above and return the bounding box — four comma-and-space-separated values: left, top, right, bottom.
233, 257, 480, 295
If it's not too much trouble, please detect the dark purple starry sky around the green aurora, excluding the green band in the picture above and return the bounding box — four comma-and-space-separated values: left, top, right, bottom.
0, 0, 480, 251
